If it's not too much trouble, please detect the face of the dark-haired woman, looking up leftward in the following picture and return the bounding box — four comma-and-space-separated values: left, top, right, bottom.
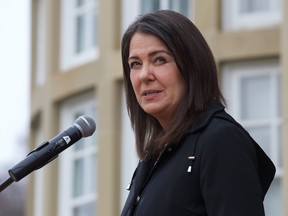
128, 33, 184, 130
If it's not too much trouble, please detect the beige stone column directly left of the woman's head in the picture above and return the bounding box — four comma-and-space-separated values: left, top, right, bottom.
97, 0, 121, 216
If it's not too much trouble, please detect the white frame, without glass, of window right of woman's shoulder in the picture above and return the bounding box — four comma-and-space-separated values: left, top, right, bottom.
222, 60, 283, 177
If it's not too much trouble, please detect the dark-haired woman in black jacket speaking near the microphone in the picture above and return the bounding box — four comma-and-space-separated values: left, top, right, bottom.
121, 11, 275, 216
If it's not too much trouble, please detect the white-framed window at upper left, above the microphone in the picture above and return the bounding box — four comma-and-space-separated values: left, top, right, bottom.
60, 0, 99, 71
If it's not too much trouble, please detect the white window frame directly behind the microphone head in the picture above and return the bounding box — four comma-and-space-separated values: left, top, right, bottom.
57, 93, 99, 216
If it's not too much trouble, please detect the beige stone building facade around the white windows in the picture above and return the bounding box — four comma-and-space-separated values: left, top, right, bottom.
26, 0, 288, 216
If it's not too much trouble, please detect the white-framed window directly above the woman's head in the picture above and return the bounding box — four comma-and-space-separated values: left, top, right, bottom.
122, 0, 194, 32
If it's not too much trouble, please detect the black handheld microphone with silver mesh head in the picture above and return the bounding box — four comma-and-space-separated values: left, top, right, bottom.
0, 116, 96, 192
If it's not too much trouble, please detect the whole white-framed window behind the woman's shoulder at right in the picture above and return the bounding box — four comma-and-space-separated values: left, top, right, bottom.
222, 60, 282, 216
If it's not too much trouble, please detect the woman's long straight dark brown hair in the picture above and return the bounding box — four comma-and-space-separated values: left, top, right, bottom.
121, 10, 225, 159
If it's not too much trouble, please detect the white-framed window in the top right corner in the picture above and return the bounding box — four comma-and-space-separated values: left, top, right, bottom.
222, 0, 282, 30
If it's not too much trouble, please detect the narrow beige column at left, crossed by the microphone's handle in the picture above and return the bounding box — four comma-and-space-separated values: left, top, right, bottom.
31, 0, 59, 216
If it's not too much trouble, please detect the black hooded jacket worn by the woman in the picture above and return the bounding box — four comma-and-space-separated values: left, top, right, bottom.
121, 102, 275, 216
